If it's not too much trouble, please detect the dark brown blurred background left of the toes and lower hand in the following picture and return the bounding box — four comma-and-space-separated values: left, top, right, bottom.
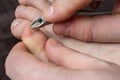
0, 0, 18, 80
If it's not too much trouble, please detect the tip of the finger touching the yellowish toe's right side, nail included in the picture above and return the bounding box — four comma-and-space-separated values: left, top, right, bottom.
46, 39, 69, 65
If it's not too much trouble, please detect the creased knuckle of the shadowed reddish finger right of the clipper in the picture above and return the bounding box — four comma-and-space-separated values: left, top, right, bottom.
68, 19, 95, 42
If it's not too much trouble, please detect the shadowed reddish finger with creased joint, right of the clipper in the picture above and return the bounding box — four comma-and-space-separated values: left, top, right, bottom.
54, 14, 120, 42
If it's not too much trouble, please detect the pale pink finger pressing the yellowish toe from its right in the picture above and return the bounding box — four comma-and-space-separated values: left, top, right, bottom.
46, 39, 108, 69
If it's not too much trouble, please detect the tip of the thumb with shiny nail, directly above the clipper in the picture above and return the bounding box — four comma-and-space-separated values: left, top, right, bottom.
43, 3, 74, 22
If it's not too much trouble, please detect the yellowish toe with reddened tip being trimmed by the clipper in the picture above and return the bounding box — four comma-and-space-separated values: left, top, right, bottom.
22, 26, 47, 62
